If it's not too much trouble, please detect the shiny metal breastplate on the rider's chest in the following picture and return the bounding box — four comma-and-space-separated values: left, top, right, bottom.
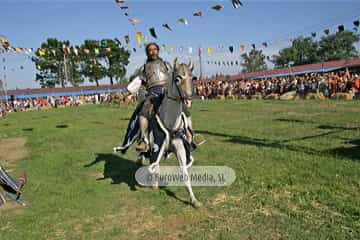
144, 60, 170, 88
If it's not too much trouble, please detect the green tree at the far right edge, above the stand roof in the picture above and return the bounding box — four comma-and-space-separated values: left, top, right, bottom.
319, 31, 360, 61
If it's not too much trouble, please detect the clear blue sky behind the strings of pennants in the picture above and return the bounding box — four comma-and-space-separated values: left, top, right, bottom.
0, 0, 360, 89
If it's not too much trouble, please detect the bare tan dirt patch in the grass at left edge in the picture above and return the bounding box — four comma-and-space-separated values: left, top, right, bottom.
0, 138, 28, 169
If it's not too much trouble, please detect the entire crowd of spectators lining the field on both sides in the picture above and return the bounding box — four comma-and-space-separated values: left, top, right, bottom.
0, 71, 360, 117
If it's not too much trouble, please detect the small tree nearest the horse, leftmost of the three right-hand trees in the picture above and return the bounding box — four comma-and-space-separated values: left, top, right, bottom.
241, 49, 267, 73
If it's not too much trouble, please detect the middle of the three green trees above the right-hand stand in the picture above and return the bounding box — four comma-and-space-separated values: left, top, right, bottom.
272, 37, 320, 68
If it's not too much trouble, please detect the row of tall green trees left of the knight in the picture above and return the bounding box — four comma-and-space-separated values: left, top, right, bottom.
32, 38, 130, 88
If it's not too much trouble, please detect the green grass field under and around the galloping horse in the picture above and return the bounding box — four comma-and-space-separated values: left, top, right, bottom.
0, 100, 360, 240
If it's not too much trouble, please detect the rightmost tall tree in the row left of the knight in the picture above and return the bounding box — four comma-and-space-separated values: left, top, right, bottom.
101, 39, 130, 85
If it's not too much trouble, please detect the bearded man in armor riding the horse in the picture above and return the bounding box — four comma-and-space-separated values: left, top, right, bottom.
123, 43, 205, 152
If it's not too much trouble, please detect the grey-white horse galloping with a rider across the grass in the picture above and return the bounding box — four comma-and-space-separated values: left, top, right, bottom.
114, 58, 202, 208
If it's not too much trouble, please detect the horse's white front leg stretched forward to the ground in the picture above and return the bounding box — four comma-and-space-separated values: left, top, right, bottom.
172, 138, 202, 208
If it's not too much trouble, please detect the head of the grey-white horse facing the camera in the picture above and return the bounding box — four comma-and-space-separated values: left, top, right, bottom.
172, 58, 194, 107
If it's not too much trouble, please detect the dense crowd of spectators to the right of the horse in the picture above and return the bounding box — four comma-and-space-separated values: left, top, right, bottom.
196, 71, 360, 99
